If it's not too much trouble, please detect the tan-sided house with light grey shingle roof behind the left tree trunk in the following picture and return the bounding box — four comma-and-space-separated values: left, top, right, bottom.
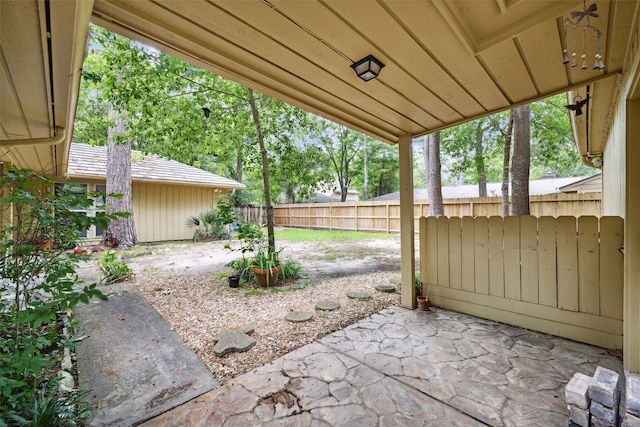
66, 143, 245, 242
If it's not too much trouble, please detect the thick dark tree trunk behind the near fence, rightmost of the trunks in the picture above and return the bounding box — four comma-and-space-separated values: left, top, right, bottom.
511, 105, 531, 216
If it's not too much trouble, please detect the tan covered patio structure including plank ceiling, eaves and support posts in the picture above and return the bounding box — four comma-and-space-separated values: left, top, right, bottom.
0, 0, 640, 372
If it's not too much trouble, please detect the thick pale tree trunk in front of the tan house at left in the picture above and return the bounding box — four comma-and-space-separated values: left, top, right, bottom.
100, 105, 138, 249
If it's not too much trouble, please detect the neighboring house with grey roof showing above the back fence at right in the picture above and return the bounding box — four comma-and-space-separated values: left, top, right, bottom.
369, 174, 602, 201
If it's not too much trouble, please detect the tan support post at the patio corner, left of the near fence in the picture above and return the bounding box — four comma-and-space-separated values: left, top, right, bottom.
398, 135, 416, 308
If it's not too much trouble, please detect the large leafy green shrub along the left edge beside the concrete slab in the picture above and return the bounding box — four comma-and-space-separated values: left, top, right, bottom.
0, 168, 124, 425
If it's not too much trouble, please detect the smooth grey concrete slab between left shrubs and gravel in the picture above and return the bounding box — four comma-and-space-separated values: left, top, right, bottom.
76, 284, 219, 426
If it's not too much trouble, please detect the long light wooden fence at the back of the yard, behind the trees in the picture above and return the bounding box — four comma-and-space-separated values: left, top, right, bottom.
258, 193, 601, 233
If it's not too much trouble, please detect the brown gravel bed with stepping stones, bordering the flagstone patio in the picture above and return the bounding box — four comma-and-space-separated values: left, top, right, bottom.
135, 272, 400, 384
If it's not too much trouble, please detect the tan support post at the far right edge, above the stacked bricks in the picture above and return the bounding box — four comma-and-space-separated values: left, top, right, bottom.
623, 96, 640, 372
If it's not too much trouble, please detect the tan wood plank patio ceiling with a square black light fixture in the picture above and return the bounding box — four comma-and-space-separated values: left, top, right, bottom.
0, 0, 638, 174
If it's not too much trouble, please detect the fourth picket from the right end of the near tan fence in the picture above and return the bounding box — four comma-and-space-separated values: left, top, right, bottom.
538, 216, 558, 307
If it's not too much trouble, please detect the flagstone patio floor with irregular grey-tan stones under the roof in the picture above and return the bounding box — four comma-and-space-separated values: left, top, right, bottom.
143, 307, 622, 427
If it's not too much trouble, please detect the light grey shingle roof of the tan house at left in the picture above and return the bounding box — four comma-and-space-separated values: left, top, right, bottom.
67, 142, 245, 190
